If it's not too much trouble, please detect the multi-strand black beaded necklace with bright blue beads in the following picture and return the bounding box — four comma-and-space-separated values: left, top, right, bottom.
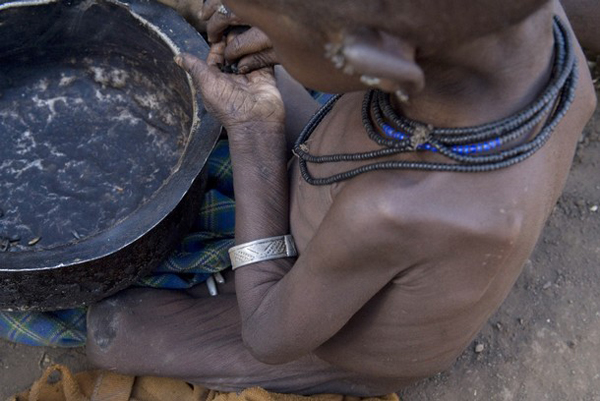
293, 17, 578, 185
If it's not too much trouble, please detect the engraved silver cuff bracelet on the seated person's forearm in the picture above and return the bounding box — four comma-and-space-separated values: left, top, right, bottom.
229, 235, 298, 270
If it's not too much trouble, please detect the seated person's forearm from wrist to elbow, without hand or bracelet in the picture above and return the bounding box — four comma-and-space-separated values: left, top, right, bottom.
229, 124, 324, 364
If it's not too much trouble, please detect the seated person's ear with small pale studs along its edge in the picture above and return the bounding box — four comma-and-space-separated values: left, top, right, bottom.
326, 28, 425, 100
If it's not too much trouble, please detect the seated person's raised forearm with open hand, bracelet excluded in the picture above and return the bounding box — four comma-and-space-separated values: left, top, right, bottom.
175, 54, 304, 359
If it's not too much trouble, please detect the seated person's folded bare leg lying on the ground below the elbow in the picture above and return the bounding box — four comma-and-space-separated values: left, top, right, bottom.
87, 289, 393, 395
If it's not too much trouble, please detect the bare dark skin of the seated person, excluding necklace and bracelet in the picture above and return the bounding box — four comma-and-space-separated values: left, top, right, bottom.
87, 0, 595, 396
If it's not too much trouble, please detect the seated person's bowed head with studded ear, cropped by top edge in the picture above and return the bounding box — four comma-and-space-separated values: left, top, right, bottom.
224, 0, 548, 92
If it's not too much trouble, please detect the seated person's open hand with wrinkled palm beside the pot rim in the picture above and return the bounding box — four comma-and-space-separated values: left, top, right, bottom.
175, 53, 285, 133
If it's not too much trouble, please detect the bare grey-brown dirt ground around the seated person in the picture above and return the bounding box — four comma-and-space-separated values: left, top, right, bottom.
0, 84, 600, 401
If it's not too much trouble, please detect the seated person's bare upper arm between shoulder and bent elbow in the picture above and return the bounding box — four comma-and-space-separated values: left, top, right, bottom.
239, 181, 402, 363
